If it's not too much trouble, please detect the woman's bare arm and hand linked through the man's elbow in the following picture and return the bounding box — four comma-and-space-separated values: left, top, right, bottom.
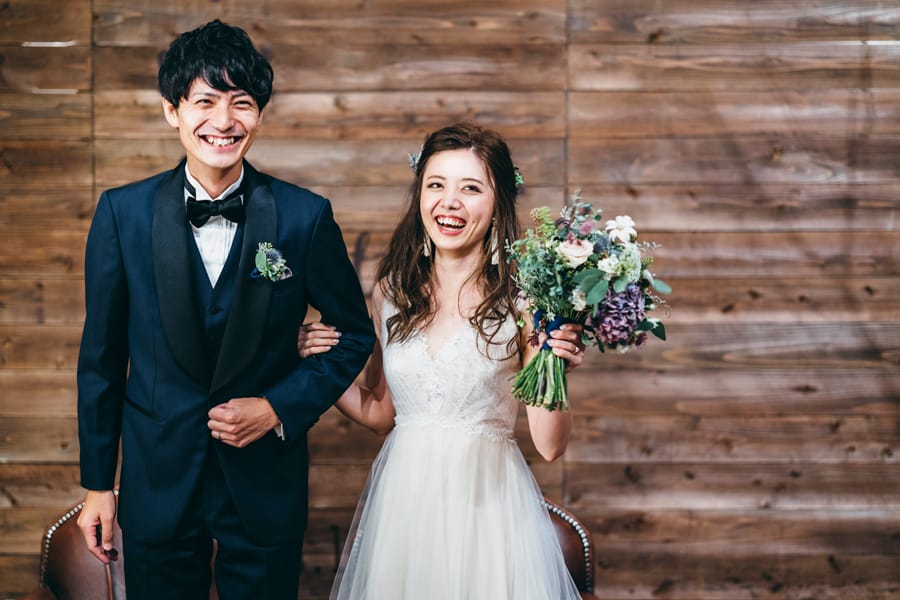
297, 286, 394, 434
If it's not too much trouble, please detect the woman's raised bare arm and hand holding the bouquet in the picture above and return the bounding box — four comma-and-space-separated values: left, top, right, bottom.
522, 318, 584, 461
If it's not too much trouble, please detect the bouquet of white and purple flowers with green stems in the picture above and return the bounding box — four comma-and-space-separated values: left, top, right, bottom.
507, 195, 671, 411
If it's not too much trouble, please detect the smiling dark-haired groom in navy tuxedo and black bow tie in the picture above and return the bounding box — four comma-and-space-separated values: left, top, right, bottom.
78, 21, 375, 600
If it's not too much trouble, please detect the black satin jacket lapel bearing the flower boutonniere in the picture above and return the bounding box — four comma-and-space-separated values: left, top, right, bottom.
210, 168, 278, 392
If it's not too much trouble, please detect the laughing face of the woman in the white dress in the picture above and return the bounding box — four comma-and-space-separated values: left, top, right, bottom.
419, 149, 494, 257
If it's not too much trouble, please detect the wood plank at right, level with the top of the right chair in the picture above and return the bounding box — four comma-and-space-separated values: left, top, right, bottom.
565, 460, 900, 508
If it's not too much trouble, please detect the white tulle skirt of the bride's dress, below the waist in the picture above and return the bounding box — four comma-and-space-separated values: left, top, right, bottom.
331, 423, 580, 600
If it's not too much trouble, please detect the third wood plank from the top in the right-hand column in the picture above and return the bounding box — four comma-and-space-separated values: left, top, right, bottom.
568, 88, 900, 137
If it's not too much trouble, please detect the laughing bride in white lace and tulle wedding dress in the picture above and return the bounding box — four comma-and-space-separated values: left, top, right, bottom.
298, 123, 583, 600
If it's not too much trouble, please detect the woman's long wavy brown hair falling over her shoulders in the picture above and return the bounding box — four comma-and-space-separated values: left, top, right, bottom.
378, 123, 519, 355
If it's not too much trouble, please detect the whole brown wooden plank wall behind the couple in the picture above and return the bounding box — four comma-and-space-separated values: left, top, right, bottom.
0, 0, 900, 600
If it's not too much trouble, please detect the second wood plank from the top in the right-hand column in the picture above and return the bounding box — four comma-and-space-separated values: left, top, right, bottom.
567, 40, 900, 91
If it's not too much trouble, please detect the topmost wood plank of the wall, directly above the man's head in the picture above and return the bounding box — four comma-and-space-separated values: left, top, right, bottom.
94, 0, 566, 48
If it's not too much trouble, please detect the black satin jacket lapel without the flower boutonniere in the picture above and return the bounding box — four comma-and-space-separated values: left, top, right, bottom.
152, 163, 209, 381
